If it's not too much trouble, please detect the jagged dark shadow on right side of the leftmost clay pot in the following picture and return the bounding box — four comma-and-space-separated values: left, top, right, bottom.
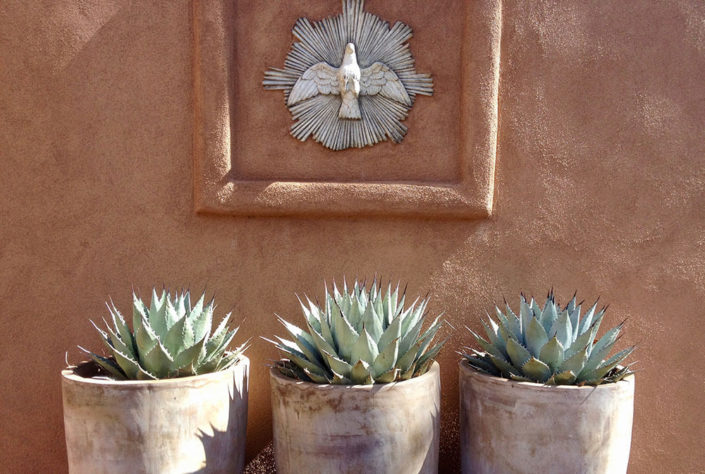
192, 373, 249, 474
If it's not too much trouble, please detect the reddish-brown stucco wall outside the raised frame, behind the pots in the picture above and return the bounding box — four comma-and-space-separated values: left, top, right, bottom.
0, 0, 705, 473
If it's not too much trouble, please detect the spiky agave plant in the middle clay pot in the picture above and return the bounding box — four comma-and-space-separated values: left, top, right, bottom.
269, 279, 443, 384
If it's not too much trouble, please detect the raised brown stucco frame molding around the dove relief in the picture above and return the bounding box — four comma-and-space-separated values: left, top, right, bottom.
192, 0, 502, 219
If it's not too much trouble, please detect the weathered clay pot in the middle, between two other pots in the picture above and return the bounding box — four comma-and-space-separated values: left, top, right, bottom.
270, 362, 441, 474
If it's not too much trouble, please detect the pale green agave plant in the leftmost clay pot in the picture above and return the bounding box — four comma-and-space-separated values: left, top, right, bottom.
79, 289, 245, 380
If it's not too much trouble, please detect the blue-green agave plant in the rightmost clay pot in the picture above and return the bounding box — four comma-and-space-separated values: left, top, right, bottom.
465, 291, 634, 385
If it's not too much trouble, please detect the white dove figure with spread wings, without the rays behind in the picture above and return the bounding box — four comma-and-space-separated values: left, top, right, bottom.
287, 43, 411, 120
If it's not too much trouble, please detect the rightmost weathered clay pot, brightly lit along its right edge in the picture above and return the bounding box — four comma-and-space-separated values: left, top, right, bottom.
460, 361, 634, 474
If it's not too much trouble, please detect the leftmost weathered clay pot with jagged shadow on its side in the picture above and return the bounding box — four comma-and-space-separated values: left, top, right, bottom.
61, 357, 249, 474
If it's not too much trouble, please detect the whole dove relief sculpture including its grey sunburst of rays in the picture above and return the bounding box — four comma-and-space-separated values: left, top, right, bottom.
263, 0, 433, 150
